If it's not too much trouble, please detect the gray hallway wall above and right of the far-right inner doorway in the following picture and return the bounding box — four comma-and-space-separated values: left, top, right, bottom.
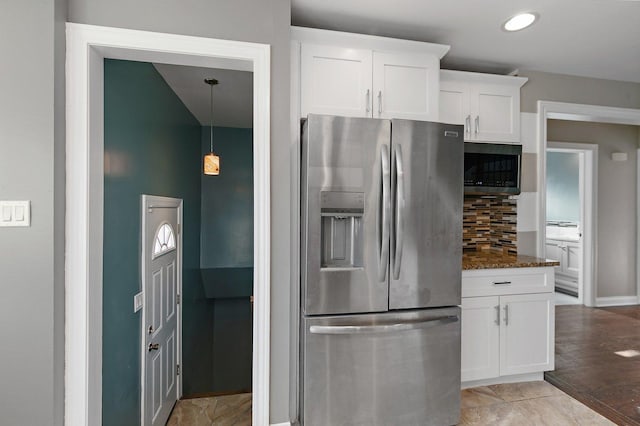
548, 120, 639, 297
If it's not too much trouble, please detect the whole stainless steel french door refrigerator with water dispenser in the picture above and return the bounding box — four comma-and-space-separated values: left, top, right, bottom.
300, 114, 463, 426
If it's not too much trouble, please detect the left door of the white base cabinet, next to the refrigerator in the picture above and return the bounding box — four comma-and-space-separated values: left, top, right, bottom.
461, 296, 500, 382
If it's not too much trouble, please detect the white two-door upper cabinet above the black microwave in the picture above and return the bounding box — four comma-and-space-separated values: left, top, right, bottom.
440, 70, 527, 143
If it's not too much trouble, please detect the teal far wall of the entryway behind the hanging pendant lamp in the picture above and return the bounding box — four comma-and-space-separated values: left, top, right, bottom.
200, 127, 253, 392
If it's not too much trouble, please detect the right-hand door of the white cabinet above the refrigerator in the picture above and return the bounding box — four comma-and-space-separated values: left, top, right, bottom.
373, 52, 440, 121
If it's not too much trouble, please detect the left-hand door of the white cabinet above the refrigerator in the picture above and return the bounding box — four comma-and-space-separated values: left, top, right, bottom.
300, 44, 372, 117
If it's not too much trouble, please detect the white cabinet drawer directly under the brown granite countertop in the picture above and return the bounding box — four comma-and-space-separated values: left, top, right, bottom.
462, 267, 554, 297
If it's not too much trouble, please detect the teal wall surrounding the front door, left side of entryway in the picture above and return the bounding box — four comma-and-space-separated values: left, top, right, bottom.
102, 60, 212, 426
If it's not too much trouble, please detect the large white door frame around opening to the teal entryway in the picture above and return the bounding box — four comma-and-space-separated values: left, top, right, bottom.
65, 23, 271, 426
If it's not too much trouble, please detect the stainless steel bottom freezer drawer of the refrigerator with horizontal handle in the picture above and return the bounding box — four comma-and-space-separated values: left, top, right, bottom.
302, 307, 460, 426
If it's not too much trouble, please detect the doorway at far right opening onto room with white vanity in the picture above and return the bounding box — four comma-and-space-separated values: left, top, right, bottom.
545, 141, 598, 305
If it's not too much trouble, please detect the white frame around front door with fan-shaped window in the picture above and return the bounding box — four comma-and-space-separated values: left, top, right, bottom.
139, 194, 184, 425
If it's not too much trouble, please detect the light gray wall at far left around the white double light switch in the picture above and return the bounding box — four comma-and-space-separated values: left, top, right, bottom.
0, 0, 66, 425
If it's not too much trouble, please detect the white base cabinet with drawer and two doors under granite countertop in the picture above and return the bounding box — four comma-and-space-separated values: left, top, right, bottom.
461, 267, 555, 386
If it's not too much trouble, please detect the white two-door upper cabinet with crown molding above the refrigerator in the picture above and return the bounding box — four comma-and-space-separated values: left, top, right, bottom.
292, 27, 448, 121
